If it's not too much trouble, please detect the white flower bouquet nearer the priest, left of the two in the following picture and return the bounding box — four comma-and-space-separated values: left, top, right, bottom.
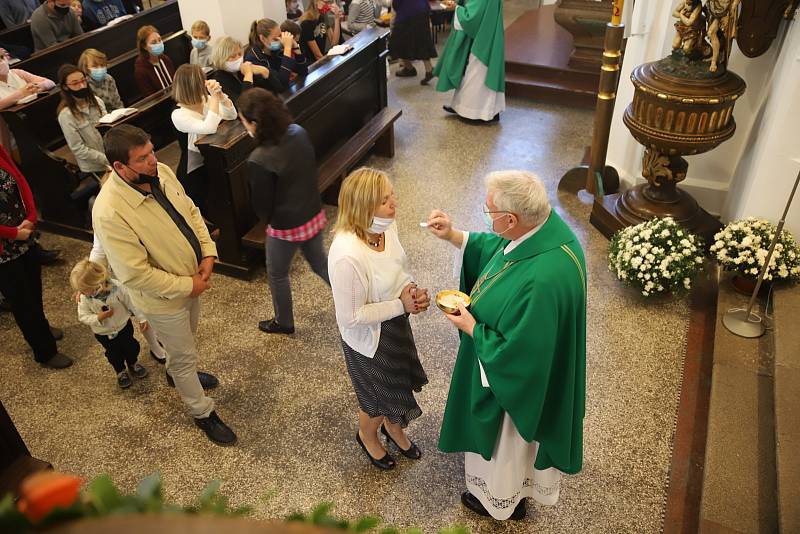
608, 217, 703, 297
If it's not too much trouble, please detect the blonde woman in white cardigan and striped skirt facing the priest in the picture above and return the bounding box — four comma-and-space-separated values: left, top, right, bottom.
328, 168, 430, 469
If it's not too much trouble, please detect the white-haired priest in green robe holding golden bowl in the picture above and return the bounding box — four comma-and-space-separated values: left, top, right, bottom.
428, 171, 586, 520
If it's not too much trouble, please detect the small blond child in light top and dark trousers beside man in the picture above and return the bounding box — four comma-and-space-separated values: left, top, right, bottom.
69, 259, 147, 389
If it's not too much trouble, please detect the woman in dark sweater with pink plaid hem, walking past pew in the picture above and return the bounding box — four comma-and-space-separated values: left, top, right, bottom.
237, 87, 330, 334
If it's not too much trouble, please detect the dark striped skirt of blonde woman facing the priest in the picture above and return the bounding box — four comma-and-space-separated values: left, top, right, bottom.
342, 315, 428, 428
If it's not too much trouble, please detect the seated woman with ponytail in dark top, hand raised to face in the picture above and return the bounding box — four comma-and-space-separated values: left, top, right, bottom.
244, 19, 308, 91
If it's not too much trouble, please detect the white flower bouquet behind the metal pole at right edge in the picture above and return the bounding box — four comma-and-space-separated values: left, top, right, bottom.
709, 217, 800, 282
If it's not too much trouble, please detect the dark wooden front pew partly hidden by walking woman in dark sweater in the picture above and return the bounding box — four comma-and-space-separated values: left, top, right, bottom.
195, 28, 400, 278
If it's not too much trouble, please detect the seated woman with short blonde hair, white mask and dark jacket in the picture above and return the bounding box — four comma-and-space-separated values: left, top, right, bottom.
211, 37, 281, 104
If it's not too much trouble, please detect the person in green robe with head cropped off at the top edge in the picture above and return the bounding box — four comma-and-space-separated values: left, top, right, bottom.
433, 0, 506, 122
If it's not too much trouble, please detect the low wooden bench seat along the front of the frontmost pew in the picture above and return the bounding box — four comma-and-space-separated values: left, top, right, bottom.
242, 108, 402, 254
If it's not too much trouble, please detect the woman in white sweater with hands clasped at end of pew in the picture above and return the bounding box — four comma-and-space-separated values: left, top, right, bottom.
172, 64, 236, 211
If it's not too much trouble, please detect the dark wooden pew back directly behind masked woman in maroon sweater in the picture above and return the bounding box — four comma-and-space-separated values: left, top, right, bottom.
14, 0, 183, 83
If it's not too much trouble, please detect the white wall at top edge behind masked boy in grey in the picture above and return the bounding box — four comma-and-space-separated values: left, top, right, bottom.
178, 0, 286, 43
